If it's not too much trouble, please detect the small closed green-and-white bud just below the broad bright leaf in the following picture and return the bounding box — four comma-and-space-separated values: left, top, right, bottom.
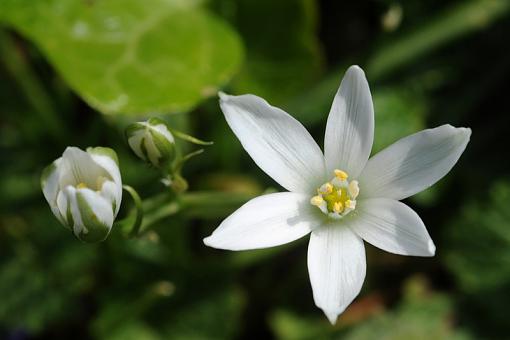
126, 118, 175, 168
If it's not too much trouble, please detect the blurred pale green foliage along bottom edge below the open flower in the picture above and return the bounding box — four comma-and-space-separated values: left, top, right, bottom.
272, 276, 470, 340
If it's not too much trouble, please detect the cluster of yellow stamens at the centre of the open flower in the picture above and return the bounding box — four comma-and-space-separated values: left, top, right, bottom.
310, 169, 359, 218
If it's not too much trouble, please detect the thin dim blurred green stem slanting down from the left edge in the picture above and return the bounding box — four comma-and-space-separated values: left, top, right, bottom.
0, 30, 65, 140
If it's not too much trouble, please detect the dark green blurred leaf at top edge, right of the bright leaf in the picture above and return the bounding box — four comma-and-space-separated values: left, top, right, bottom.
225, 0, 322, 104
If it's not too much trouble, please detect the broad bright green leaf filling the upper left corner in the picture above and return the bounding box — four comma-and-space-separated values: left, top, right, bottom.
0, 0, 243, 114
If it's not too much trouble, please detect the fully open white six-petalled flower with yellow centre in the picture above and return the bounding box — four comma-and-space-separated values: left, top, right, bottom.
204, 66, 471, 323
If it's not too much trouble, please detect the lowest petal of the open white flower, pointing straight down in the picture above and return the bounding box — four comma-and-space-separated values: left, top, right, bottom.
308, 225, 366, 324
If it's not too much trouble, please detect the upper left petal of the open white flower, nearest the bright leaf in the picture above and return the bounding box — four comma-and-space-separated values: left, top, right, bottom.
220, 93, 325, 193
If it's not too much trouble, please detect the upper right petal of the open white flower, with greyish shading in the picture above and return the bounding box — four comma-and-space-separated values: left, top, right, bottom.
359, 125, 471, 200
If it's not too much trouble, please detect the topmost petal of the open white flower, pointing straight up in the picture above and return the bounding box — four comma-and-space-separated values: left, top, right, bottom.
324, 66, 374, 178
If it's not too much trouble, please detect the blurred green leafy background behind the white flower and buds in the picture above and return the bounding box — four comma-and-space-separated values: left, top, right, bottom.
0, 0, 510, 340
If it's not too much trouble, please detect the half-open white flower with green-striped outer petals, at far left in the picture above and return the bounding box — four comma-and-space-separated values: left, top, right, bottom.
41, 147, 122, 242
